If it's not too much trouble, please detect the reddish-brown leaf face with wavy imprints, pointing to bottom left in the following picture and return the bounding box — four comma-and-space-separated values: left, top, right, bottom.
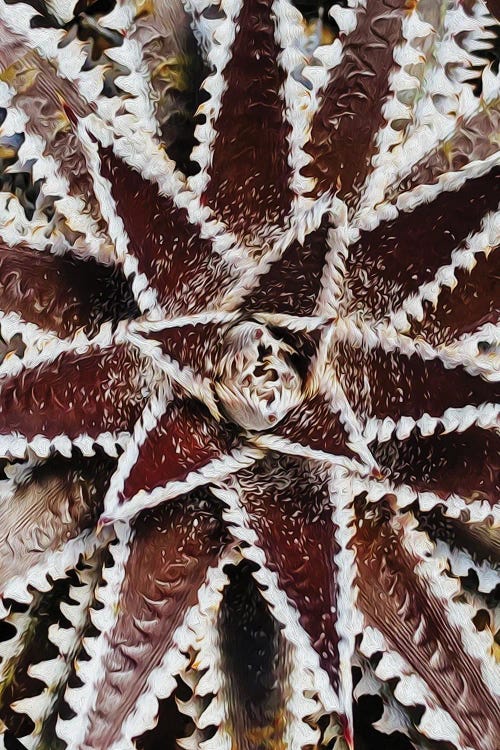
84, 490, 227, 748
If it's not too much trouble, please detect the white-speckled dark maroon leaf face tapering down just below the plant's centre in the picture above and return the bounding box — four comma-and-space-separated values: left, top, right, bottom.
238, 454, 339, 690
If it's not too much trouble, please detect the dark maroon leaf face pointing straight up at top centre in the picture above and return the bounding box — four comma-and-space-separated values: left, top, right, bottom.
205, 0, 292, 234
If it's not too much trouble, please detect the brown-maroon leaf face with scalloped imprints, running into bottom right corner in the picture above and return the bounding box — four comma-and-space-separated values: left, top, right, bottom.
354, 502, 499, 750
